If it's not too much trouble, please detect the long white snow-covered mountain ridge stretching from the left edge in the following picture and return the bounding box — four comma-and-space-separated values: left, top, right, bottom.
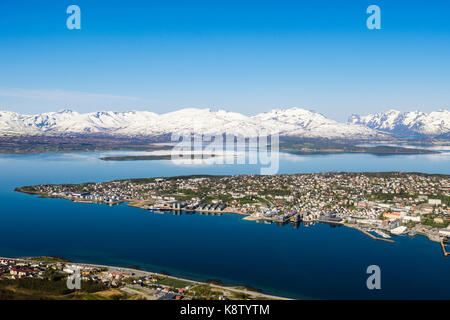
0, 108, 383, 139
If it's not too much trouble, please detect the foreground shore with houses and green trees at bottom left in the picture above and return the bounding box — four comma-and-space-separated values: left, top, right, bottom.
0, 257, 284, 300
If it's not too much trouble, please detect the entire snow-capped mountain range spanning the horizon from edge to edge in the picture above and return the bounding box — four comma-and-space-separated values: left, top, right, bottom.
0, 108, 450, 140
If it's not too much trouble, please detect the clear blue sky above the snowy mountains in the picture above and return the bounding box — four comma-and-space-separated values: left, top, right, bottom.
0, 0, 450, 120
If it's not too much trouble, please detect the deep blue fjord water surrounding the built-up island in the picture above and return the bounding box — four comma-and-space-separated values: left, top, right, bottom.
0, 152, 450, 299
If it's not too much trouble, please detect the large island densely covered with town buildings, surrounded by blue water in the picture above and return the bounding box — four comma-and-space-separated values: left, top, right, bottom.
16, 172, 450, 255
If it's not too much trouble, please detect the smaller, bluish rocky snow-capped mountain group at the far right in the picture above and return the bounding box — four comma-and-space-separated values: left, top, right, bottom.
348, 110, 450, 136
